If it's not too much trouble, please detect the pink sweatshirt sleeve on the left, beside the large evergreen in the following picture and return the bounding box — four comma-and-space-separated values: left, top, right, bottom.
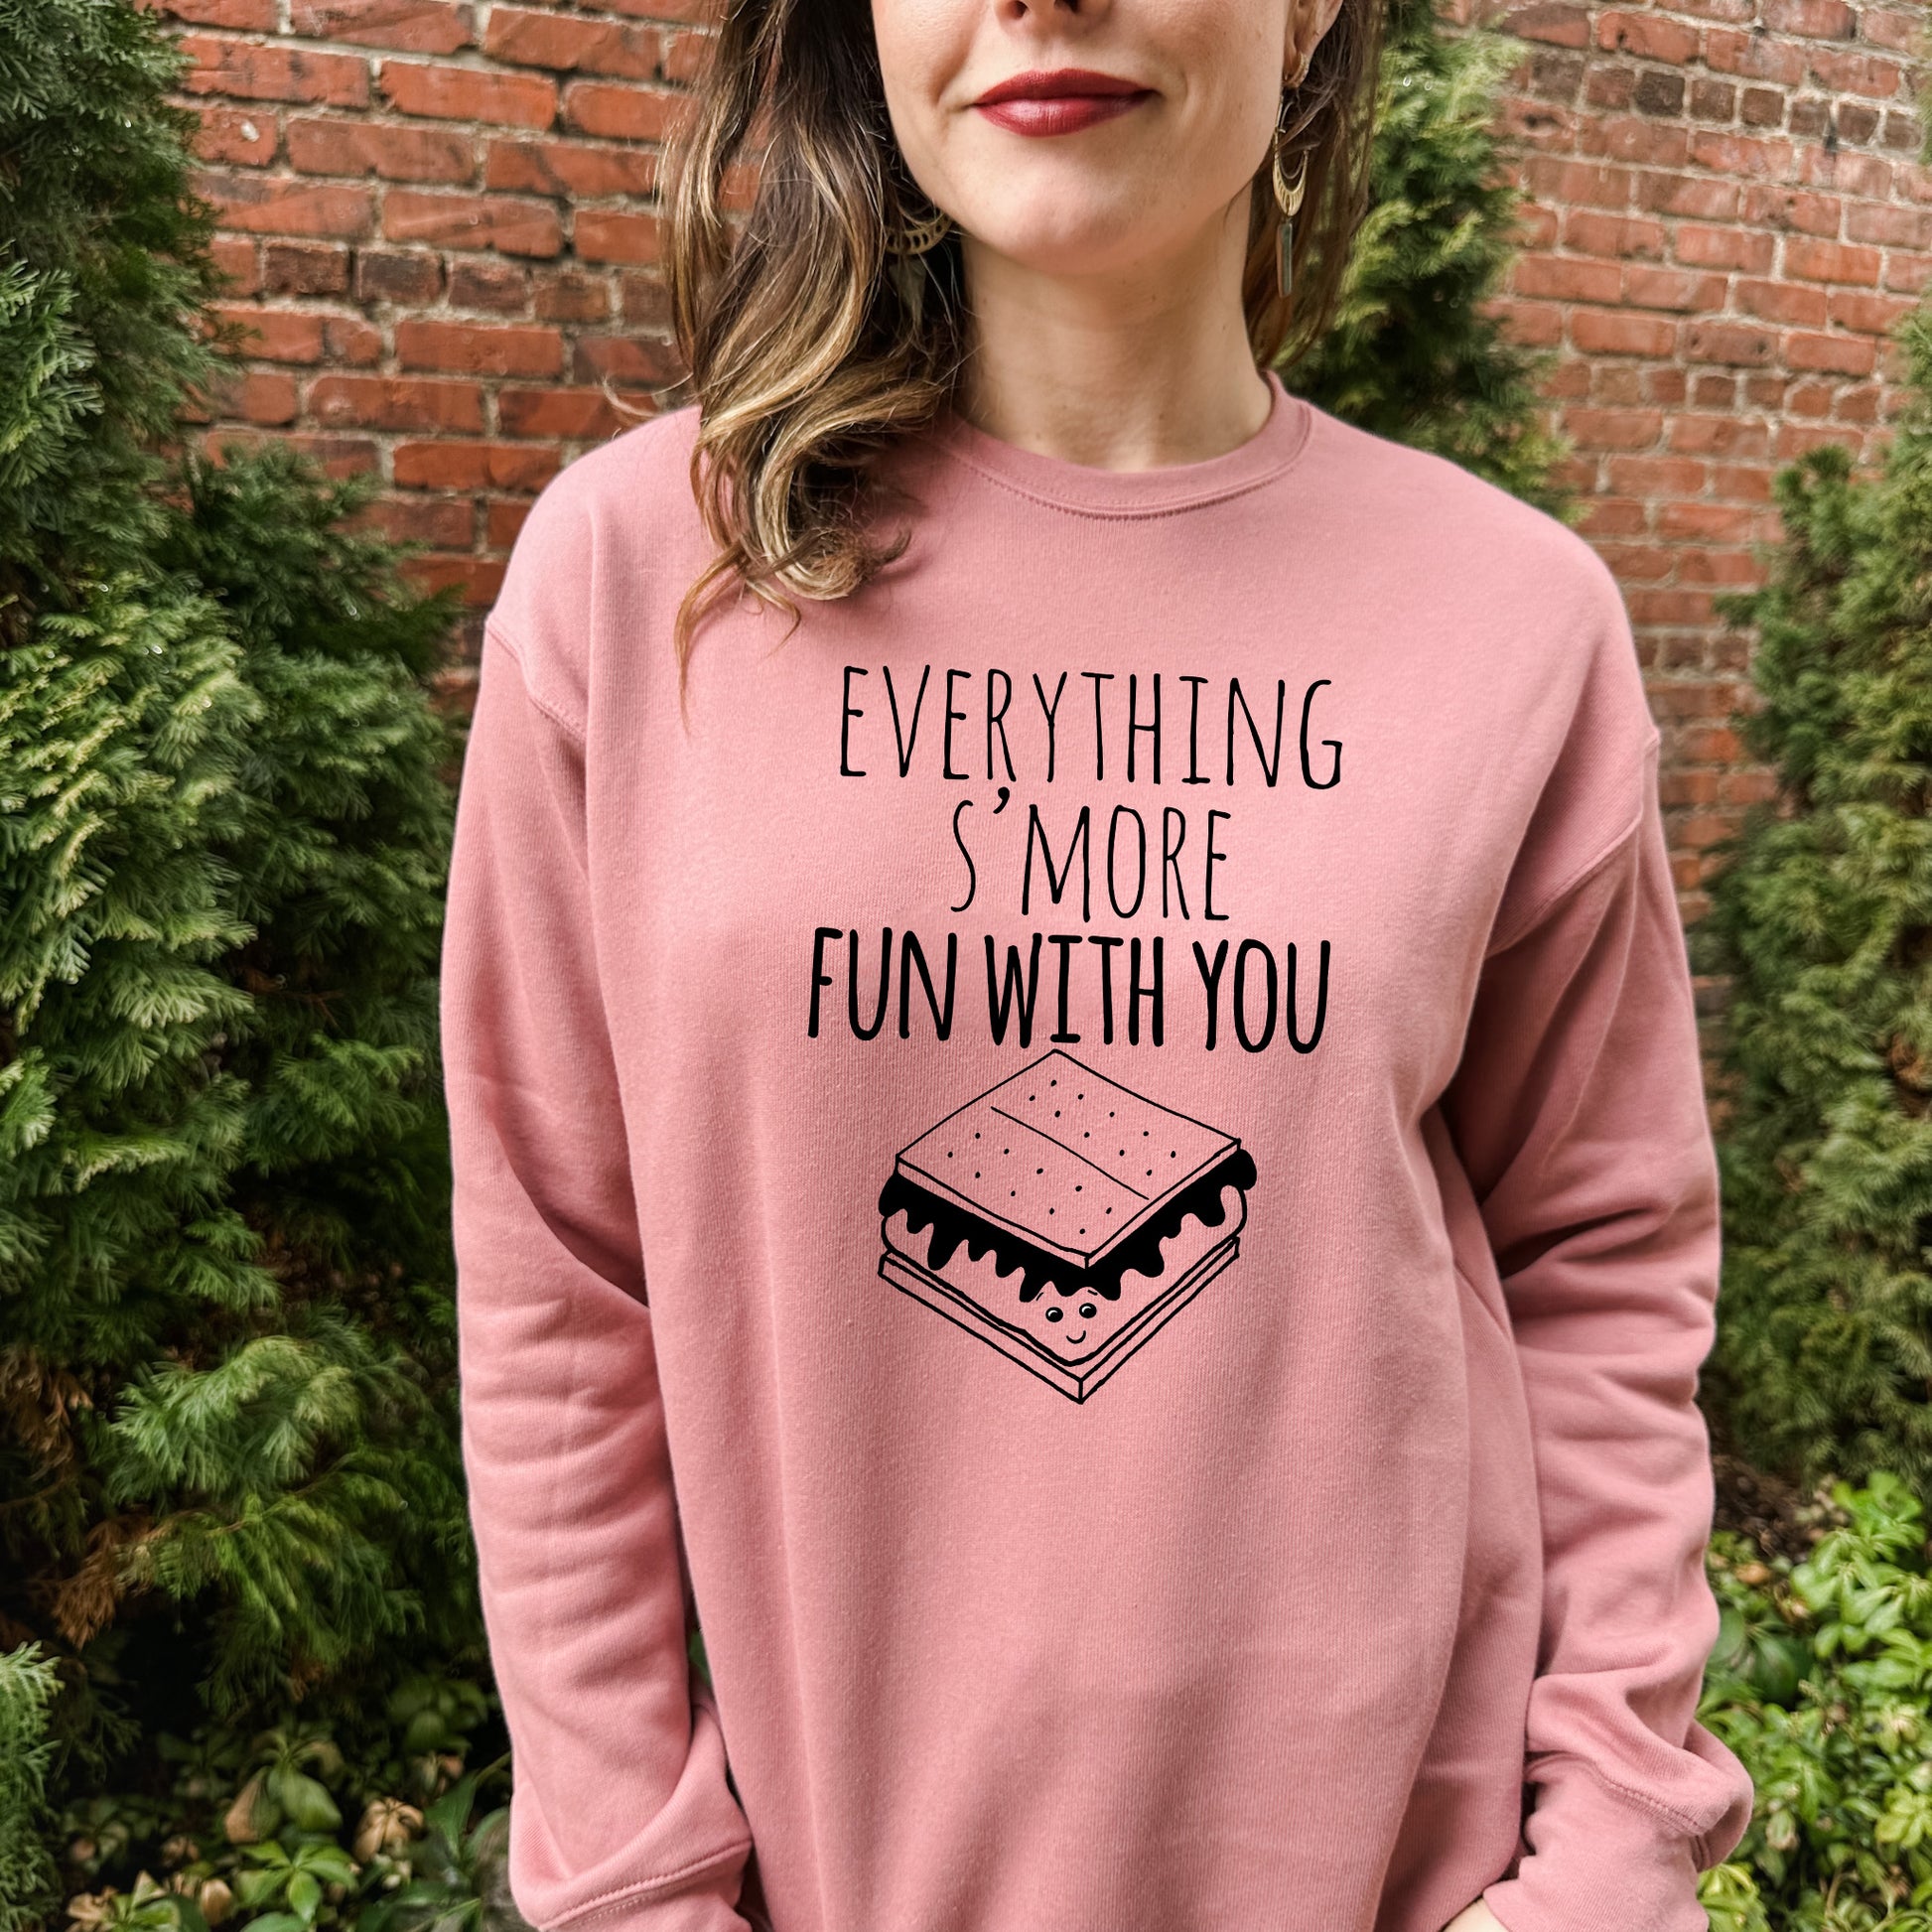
441, 607, 750, 1932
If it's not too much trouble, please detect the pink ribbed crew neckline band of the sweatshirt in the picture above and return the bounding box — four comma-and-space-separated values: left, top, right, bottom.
933, 369, 1313, 516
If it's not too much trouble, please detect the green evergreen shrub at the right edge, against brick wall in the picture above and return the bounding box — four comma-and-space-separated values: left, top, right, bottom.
1693, 315, 1932, 1487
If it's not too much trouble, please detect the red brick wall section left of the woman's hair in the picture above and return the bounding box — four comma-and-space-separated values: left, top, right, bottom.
164, 0, 701, 607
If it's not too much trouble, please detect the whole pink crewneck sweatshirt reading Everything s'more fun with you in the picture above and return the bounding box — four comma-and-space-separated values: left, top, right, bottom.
443, 372, 1752, 1932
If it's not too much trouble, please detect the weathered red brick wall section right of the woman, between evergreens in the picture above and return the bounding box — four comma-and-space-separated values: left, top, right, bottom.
1509, 0, 1932, 919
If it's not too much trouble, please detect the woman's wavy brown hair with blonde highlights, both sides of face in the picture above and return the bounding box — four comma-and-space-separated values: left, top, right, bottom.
664, 0, 1387, 688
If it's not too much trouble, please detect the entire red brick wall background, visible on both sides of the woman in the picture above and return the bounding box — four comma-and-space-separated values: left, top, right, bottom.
151, 0, 1932, 938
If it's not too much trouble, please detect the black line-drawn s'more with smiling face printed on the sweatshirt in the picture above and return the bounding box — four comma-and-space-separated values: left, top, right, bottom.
879, 1051, 1256, 1403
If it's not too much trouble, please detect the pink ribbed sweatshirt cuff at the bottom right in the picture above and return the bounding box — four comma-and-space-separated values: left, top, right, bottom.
1482, 1764, 1710, 1932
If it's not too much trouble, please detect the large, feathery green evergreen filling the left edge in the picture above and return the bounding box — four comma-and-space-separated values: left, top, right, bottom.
0, 0, 480, 1839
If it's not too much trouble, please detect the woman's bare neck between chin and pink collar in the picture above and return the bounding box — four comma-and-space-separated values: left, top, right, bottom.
956, 197, 1270, 470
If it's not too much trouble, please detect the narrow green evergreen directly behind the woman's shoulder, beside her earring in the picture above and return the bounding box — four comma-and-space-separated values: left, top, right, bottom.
1287, 0, 1559, 510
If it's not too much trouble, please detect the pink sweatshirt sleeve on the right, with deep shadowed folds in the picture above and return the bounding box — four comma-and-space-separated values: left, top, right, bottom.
1444, 687, 1752, 1932
